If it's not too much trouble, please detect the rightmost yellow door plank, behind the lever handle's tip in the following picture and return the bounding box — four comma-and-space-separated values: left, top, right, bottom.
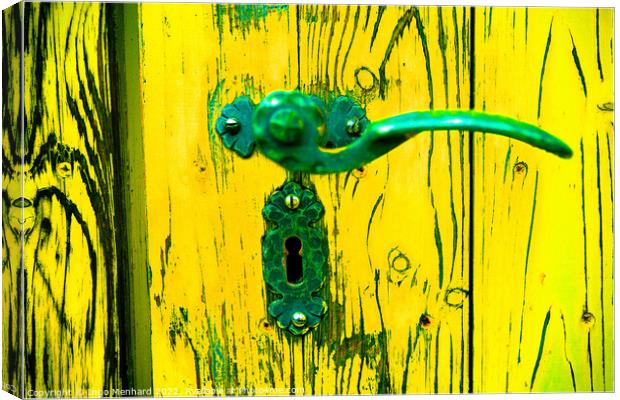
473, 8, 614, 392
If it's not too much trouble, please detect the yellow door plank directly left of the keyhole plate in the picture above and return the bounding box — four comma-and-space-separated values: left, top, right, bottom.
140, 4, 297, 395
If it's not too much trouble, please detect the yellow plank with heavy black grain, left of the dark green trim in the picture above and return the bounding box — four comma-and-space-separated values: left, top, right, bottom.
3, 3, 120, 397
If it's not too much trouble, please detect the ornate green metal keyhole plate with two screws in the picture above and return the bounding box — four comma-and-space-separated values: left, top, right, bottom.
262, 181, 328, 335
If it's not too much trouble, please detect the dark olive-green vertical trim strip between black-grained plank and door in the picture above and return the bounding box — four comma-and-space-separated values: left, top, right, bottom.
106, 3, 153, 390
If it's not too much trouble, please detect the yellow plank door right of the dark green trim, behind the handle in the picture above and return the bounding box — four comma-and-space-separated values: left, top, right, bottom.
133, 5, 613, 394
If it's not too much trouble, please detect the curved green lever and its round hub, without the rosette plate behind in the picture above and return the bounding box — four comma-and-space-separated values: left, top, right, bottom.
218, 91, 572, 174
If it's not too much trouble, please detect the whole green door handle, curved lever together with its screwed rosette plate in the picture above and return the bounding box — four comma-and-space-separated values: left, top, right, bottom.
216, 91, 572, 174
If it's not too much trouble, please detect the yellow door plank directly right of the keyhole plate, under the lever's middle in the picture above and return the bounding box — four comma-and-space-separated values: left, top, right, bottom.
298, 6, 469, 394
